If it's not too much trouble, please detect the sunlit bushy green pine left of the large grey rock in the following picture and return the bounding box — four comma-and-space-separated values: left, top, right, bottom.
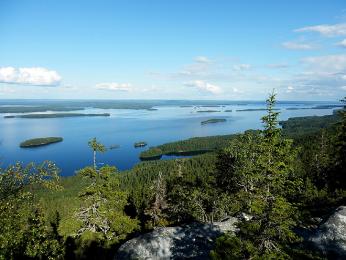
76, 166, 137, 245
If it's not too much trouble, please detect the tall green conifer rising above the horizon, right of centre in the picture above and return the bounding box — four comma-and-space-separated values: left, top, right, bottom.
214, 94, 302, 259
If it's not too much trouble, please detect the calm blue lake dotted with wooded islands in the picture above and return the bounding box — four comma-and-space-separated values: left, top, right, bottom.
0, 101, 340, 176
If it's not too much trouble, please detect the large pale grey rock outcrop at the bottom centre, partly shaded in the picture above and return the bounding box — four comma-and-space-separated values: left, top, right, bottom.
115, 218, 237, 260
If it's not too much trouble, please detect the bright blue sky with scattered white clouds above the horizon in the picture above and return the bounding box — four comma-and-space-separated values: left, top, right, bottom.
0, 0, 346, 100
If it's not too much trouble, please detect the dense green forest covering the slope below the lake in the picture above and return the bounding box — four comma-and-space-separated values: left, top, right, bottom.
0, 94, 346, 259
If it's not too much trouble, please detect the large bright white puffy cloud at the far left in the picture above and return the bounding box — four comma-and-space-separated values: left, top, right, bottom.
0, 67, 61, 86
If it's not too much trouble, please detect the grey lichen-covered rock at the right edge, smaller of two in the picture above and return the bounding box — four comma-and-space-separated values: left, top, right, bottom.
309, 206, 346, 259
